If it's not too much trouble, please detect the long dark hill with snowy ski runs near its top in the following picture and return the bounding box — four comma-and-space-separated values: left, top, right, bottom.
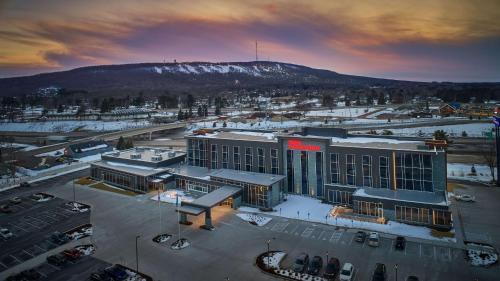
0, 61, 406, 96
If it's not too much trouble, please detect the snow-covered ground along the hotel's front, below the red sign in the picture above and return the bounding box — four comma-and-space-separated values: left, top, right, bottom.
238, 195, 456, 242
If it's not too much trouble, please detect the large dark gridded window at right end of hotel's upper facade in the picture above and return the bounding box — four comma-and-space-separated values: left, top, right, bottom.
396, 153, 434, 192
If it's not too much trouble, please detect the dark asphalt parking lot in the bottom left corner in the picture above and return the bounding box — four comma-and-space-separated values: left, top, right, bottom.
0, 191, 90, 272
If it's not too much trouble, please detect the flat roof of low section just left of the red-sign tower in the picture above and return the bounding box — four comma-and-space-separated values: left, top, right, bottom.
210, 169, 285, 186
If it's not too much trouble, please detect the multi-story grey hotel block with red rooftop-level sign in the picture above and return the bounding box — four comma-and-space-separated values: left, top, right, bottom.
186, 128, 451, 227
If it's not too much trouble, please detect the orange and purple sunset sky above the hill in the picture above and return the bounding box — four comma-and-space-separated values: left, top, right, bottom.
0, 0, 500, 82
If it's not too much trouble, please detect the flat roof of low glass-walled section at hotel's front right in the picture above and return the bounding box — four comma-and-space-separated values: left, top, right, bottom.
353, 188, 449, 206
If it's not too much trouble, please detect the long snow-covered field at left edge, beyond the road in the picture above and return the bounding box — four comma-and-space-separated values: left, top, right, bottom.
0, 120, 149, 132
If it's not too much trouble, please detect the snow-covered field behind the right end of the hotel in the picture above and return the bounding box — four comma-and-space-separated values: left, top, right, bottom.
386, 122, 493, 137
